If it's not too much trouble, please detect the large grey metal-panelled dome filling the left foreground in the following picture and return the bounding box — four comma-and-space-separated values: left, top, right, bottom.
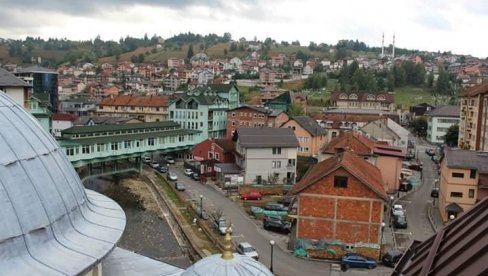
0, 91, 125, 275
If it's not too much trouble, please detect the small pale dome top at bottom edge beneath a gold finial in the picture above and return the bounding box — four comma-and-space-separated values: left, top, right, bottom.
181, 253, 273, 276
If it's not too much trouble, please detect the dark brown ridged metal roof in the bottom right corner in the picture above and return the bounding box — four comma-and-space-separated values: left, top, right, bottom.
391, 198, 488, 276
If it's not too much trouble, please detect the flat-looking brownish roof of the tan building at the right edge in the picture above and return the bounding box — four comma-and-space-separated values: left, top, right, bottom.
444, 147, 488, 173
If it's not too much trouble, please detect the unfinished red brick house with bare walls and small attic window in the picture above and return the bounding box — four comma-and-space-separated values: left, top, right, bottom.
289, 149, 388, 259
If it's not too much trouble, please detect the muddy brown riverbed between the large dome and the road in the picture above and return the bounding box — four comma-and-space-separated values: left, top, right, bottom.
87, 176, 191, 267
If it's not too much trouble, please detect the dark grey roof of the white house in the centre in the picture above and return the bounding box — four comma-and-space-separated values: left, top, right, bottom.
236, 127, 300, 148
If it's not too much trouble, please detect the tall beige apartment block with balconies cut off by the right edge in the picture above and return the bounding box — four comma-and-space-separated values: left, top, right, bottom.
458, 82, 488, 151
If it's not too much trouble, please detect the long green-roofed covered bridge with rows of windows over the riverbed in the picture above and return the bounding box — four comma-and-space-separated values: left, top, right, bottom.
58, 121, 202, 181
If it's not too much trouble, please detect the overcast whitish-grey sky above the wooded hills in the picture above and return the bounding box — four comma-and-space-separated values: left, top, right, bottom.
0, 0, 488, 58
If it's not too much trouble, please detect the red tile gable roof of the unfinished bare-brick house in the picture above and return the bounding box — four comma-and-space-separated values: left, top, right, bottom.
290, 151, 388, 200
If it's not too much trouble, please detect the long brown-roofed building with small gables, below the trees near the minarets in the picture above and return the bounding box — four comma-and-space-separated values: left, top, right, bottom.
330, 91, 395, 112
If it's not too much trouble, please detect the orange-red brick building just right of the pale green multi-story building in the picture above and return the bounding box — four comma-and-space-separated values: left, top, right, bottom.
227, 105, 289, 138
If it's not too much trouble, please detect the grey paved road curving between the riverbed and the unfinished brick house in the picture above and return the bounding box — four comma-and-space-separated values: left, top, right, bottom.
164, 165, 391, 276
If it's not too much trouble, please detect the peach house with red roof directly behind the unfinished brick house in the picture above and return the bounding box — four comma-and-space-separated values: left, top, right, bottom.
319, 131, 406, 192
